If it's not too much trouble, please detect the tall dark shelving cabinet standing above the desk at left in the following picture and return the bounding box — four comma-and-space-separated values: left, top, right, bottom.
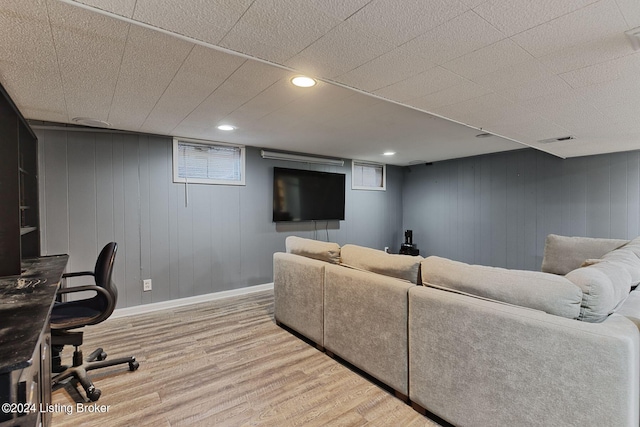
0, 82, 40, 277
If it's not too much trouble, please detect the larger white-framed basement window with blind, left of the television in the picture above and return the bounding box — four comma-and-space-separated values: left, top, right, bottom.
173, 138, 245, 185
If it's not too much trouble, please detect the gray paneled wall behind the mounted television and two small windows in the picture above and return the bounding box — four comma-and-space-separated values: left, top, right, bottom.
36, 130, 403, 307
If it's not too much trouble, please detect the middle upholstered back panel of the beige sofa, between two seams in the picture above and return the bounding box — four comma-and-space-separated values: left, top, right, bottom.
324, 265, 415, 395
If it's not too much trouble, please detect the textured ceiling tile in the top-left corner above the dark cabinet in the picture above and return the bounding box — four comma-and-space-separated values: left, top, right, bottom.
0, 0, 68, 121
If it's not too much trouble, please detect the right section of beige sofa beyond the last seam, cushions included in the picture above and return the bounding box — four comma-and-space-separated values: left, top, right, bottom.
409, 236, 640, 426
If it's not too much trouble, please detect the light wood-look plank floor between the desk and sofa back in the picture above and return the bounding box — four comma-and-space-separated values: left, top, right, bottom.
52, 291, 437, 427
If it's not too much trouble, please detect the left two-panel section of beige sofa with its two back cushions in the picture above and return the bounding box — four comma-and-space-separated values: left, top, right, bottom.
273, 237, 423, 400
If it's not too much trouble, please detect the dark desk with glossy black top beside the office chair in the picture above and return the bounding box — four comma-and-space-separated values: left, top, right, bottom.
0, 255, 69, 427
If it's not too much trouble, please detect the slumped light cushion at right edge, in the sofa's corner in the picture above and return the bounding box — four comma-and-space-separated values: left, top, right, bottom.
565, 238, 640, 322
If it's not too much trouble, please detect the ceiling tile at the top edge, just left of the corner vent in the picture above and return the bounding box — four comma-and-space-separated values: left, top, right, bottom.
512, 0, 626, 57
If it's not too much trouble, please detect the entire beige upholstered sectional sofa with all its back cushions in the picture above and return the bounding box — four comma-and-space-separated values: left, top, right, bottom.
274, 235, 640, 426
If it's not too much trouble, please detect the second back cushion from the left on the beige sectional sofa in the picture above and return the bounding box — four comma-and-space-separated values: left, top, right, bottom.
340, 245, 424, 284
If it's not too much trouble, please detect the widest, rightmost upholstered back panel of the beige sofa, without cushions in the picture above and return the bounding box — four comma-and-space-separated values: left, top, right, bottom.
409, 287, 640, 427
